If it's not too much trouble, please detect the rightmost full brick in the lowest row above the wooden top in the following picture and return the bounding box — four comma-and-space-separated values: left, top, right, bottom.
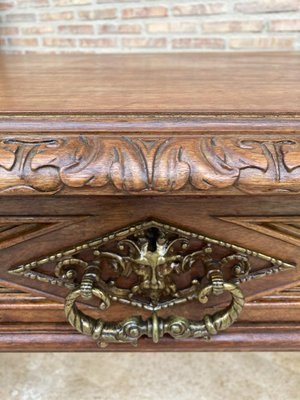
229, 37, 294, 50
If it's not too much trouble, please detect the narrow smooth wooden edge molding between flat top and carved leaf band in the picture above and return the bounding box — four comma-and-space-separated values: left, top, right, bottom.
0, 111, 300, 136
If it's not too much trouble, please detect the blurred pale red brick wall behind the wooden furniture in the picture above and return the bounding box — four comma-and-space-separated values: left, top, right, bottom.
0, 0, 300, 53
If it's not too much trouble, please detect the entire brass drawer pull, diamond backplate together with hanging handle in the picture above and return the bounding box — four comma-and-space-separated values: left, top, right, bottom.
9, 221, 294, 343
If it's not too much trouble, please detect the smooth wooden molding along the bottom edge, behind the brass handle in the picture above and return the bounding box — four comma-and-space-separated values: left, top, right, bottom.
0, 322, 300, 352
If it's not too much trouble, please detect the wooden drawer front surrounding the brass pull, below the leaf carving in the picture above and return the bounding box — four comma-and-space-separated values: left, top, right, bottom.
0, 196, 300, 351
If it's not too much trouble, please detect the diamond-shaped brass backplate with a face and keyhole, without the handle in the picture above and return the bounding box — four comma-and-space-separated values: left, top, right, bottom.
10, 221, 294, 311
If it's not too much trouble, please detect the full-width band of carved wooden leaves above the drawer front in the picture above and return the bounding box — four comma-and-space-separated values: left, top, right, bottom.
0, 135, 300, 194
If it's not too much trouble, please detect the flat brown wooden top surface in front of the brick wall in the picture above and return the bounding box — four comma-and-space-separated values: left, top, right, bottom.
0, 53, 300, 114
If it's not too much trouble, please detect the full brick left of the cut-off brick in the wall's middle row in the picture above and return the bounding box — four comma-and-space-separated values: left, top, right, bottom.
202, 20, 264, 33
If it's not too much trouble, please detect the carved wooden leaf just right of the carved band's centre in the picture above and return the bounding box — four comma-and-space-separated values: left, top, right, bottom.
153, 138, 268, 191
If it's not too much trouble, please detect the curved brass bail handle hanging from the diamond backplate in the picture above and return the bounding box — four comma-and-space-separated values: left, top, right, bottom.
65, 279, 244, 347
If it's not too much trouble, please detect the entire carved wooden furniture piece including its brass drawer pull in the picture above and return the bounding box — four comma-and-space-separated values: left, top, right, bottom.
0, 53, 300, 351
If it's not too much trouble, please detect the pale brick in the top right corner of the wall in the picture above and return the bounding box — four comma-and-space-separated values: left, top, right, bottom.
235, 0, 300, 14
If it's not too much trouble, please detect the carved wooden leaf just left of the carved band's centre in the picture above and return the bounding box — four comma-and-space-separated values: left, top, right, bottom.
32, 136, 147, 191
